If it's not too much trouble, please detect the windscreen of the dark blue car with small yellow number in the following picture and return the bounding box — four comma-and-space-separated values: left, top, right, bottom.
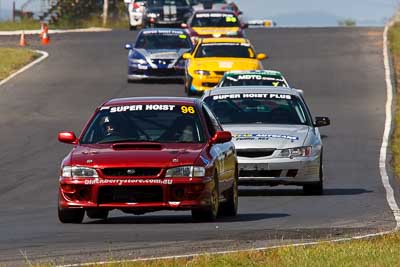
135, 31, 192, 49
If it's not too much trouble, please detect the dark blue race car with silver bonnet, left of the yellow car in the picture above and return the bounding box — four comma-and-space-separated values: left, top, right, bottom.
125, 29, 193, 81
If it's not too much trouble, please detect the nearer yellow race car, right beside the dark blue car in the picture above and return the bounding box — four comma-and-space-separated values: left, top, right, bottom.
183, 38, 267, 96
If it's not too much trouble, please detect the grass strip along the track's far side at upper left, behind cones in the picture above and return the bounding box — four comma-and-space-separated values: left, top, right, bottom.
0, 16, 129, 31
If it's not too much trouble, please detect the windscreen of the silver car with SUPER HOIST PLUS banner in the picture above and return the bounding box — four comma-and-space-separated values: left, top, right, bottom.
205, 93, 311, 125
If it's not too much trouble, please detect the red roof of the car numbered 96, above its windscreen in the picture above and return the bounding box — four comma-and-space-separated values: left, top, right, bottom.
102, 97, 201, 106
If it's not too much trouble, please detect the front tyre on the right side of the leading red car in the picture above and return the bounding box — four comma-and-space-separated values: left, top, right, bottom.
192, 176, 219, 222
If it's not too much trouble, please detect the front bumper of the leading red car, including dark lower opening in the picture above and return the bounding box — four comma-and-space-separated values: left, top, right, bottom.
59, 177, 212, 212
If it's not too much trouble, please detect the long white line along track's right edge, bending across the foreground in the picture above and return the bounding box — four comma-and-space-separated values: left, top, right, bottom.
55, 21, 400, 267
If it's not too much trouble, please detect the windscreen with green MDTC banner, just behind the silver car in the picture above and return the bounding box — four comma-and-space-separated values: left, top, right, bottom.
220, 74, 287, 87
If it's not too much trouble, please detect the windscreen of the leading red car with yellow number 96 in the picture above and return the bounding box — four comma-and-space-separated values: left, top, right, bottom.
80, 104, 205, 144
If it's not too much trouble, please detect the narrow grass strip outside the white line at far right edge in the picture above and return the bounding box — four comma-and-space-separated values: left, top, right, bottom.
389, 23, 400, 178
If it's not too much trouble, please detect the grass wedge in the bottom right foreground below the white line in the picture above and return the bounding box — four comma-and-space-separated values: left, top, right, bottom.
76, 233, 400, 267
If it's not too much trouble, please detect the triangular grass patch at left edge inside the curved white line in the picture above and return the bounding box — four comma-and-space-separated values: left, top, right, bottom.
0, 48, 39, 81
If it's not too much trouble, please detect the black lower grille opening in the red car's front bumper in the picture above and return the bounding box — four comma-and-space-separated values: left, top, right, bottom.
97, 186, 163, 204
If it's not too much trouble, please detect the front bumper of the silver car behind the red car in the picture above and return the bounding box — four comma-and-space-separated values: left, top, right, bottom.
238, 155, 320, 186
